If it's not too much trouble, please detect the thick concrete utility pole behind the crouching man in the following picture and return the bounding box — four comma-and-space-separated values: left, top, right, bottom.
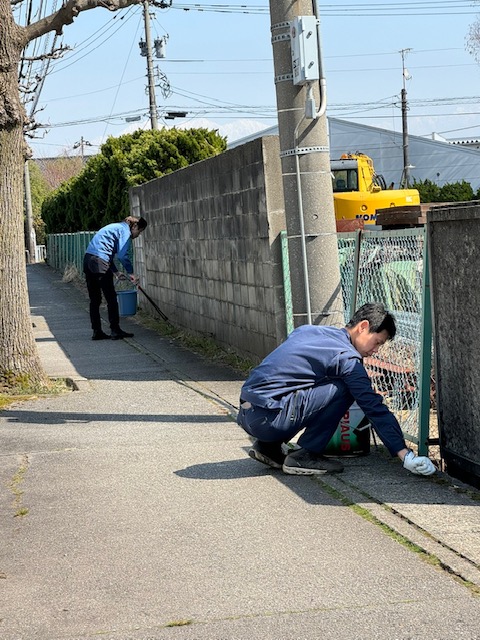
270, 0, 345, 326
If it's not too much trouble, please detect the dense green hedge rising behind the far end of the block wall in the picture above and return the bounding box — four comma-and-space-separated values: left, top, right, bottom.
42, 129, 227, 233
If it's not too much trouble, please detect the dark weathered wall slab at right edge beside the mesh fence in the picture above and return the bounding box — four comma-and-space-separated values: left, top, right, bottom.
427, 201, 480, 488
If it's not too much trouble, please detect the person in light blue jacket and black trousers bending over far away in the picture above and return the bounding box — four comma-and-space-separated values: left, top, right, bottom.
83, 216, 147, 340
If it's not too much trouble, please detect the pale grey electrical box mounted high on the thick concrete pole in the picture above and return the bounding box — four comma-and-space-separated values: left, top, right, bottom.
290, 16, 320, 85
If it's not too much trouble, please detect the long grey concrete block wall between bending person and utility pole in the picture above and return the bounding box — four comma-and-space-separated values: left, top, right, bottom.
130, 136, 286, 361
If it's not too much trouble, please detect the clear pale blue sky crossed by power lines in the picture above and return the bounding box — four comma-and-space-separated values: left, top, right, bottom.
15, 0, 480, 157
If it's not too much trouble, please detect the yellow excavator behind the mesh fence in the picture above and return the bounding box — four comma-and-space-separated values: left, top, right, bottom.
330, 152, 420, 224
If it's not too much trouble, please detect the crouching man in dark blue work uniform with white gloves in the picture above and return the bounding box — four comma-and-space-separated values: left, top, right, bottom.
237, 303, 435, 476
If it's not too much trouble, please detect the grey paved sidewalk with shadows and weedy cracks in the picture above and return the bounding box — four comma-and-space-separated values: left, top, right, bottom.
0, 264, 480, 640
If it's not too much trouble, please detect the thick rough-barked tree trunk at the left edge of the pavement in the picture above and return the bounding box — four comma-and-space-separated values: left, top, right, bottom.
0, 0, 48, 386
